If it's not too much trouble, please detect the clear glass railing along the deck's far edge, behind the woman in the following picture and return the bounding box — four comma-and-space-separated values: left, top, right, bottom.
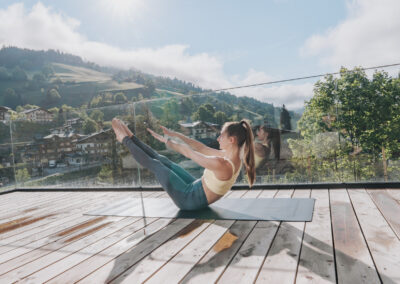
0, 69, 400, 190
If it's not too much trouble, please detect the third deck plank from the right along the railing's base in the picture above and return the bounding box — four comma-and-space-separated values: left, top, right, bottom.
348, 189, 400, 284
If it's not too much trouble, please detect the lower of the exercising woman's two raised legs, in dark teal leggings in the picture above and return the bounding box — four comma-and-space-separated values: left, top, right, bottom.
122, 136, 207, 209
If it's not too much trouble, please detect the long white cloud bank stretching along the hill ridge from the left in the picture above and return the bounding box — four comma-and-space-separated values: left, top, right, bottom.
0, 2, 312, 109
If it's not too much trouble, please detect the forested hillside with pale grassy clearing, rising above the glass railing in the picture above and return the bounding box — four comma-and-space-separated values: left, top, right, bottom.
0, 47, 299, 129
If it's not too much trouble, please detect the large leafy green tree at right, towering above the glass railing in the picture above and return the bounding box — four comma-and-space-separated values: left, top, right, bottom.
298, 68, 400, 180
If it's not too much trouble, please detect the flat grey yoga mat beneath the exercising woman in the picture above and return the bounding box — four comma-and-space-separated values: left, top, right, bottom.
85, 198, 315, 222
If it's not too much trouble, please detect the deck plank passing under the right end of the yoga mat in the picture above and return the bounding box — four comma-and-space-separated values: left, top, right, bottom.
256, 190, 310, 283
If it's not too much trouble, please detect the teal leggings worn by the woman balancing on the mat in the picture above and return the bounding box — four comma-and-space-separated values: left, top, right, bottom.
122, 136, 208, 210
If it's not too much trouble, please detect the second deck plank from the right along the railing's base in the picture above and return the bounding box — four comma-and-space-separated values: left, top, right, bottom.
368, 189, 400, 239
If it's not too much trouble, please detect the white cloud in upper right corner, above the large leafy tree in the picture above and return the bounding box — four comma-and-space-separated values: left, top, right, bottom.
301, 0, 400, 70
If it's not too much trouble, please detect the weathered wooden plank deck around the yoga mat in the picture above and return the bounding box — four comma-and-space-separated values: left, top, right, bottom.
0, 189, 400, 284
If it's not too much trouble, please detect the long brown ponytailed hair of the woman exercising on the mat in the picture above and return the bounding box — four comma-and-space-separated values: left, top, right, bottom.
226, 120, 256, 187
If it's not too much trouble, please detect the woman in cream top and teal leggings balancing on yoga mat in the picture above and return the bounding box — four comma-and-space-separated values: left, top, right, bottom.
112, 118, 255, 210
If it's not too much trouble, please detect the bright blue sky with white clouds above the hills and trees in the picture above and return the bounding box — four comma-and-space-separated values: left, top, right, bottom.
0, 0, 400, 110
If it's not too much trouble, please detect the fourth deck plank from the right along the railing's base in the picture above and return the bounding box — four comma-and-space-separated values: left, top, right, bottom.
329, 189, 380, 284
